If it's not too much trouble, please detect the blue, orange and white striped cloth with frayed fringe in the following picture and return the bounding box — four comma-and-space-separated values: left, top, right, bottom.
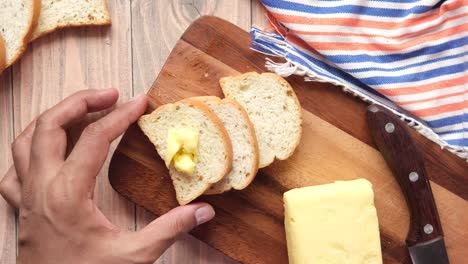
251, 0, 468, 159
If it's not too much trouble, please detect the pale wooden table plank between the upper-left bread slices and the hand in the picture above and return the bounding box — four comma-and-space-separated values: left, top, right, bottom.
13, 0, 135, 233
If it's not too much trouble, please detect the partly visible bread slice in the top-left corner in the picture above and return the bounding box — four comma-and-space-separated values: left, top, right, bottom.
0, 0, 41, 67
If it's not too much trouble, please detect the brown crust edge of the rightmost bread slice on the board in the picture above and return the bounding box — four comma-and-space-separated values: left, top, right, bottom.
219, 72, 303, 165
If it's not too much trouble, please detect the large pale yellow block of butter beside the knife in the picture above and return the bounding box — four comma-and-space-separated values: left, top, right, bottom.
283, 179, 382, 264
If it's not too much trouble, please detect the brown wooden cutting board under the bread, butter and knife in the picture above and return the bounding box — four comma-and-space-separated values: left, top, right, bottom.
109, 17, 468, 264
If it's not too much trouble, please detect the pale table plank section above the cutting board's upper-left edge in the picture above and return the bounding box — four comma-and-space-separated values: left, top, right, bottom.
132, 0, 252, 93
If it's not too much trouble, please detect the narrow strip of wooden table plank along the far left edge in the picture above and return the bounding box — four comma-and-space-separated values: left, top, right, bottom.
0, 70, 16, 264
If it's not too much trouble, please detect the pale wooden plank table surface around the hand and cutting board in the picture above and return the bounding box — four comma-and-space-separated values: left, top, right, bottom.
0, 0, 267, 264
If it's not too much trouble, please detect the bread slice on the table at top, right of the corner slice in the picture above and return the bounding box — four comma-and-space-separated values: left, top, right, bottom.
32, 0, 111, 40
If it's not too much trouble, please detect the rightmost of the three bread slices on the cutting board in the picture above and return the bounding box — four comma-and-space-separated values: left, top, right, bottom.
220, 72, 302, 168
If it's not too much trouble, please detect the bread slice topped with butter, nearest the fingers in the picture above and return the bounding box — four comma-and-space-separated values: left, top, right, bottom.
138, 100, 232, 205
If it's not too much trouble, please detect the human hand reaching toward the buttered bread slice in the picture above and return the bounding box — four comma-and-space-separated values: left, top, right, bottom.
0, 89, 214, 264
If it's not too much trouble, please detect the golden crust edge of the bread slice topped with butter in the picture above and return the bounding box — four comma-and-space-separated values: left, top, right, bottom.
138, 99, 232, 205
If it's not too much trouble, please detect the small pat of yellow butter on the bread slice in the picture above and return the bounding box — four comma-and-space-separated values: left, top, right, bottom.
164, 128, 199, 175
